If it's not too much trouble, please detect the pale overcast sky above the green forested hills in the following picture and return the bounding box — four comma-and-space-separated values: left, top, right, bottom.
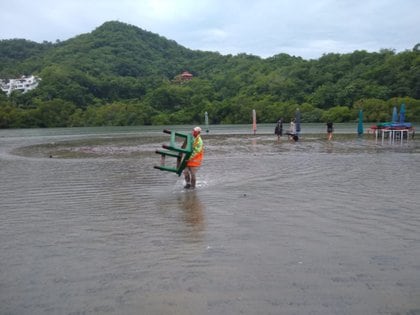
0, 0, 420, 59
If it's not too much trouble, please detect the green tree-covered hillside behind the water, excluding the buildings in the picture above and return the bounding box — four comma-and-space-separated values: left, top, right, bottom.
0, 22, 420, 128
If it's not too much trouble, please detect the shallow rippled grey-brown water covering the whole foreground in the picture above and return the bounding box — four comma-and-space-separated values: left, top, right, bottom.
0, 124, 420, 315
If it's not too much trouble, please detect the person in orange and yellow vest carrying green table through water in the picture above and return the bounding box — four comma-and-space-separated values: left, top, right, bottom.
184, 127, 204, 189
